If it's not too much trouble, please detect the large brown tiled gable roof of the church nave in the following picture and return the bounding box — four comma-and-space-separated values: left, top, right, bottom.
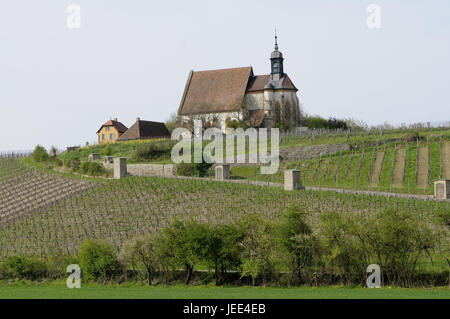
179, 66, 253, 115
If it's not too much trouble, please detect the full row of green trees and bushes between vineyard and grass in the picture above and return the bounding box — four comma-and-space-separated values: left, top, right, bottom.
0, 207, 450, 287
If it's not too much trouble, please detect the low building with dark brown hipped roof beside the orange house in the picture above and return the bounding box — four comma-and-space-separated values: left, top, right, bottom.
118, 117, 171, 141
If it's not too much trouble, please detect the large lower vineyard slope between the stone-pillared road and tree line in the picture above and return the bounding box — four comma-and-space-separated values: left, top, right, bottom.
0, 155, 450, 258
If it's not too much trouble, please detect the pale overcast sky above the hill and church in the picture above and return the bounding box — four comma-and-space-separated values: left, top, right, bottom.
0, 0, 450, 150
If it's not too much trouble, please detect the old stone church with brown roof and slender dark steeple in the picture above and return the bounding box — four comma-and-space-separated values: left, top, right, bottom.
178, 36, 300, 132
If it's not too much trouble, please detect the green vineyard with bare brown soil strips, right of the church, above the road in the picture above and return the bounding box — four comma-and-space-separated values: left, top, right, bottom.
232, 136, 450, 194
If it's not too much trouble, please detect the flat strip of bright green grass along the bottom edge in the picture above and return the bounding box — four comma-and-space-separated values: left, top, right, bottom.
0, 285, 450, 299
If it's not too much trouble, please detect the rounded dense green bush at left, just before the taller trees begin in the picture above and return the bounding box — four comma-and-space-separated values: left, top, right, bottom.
78, 240, 119, 280
